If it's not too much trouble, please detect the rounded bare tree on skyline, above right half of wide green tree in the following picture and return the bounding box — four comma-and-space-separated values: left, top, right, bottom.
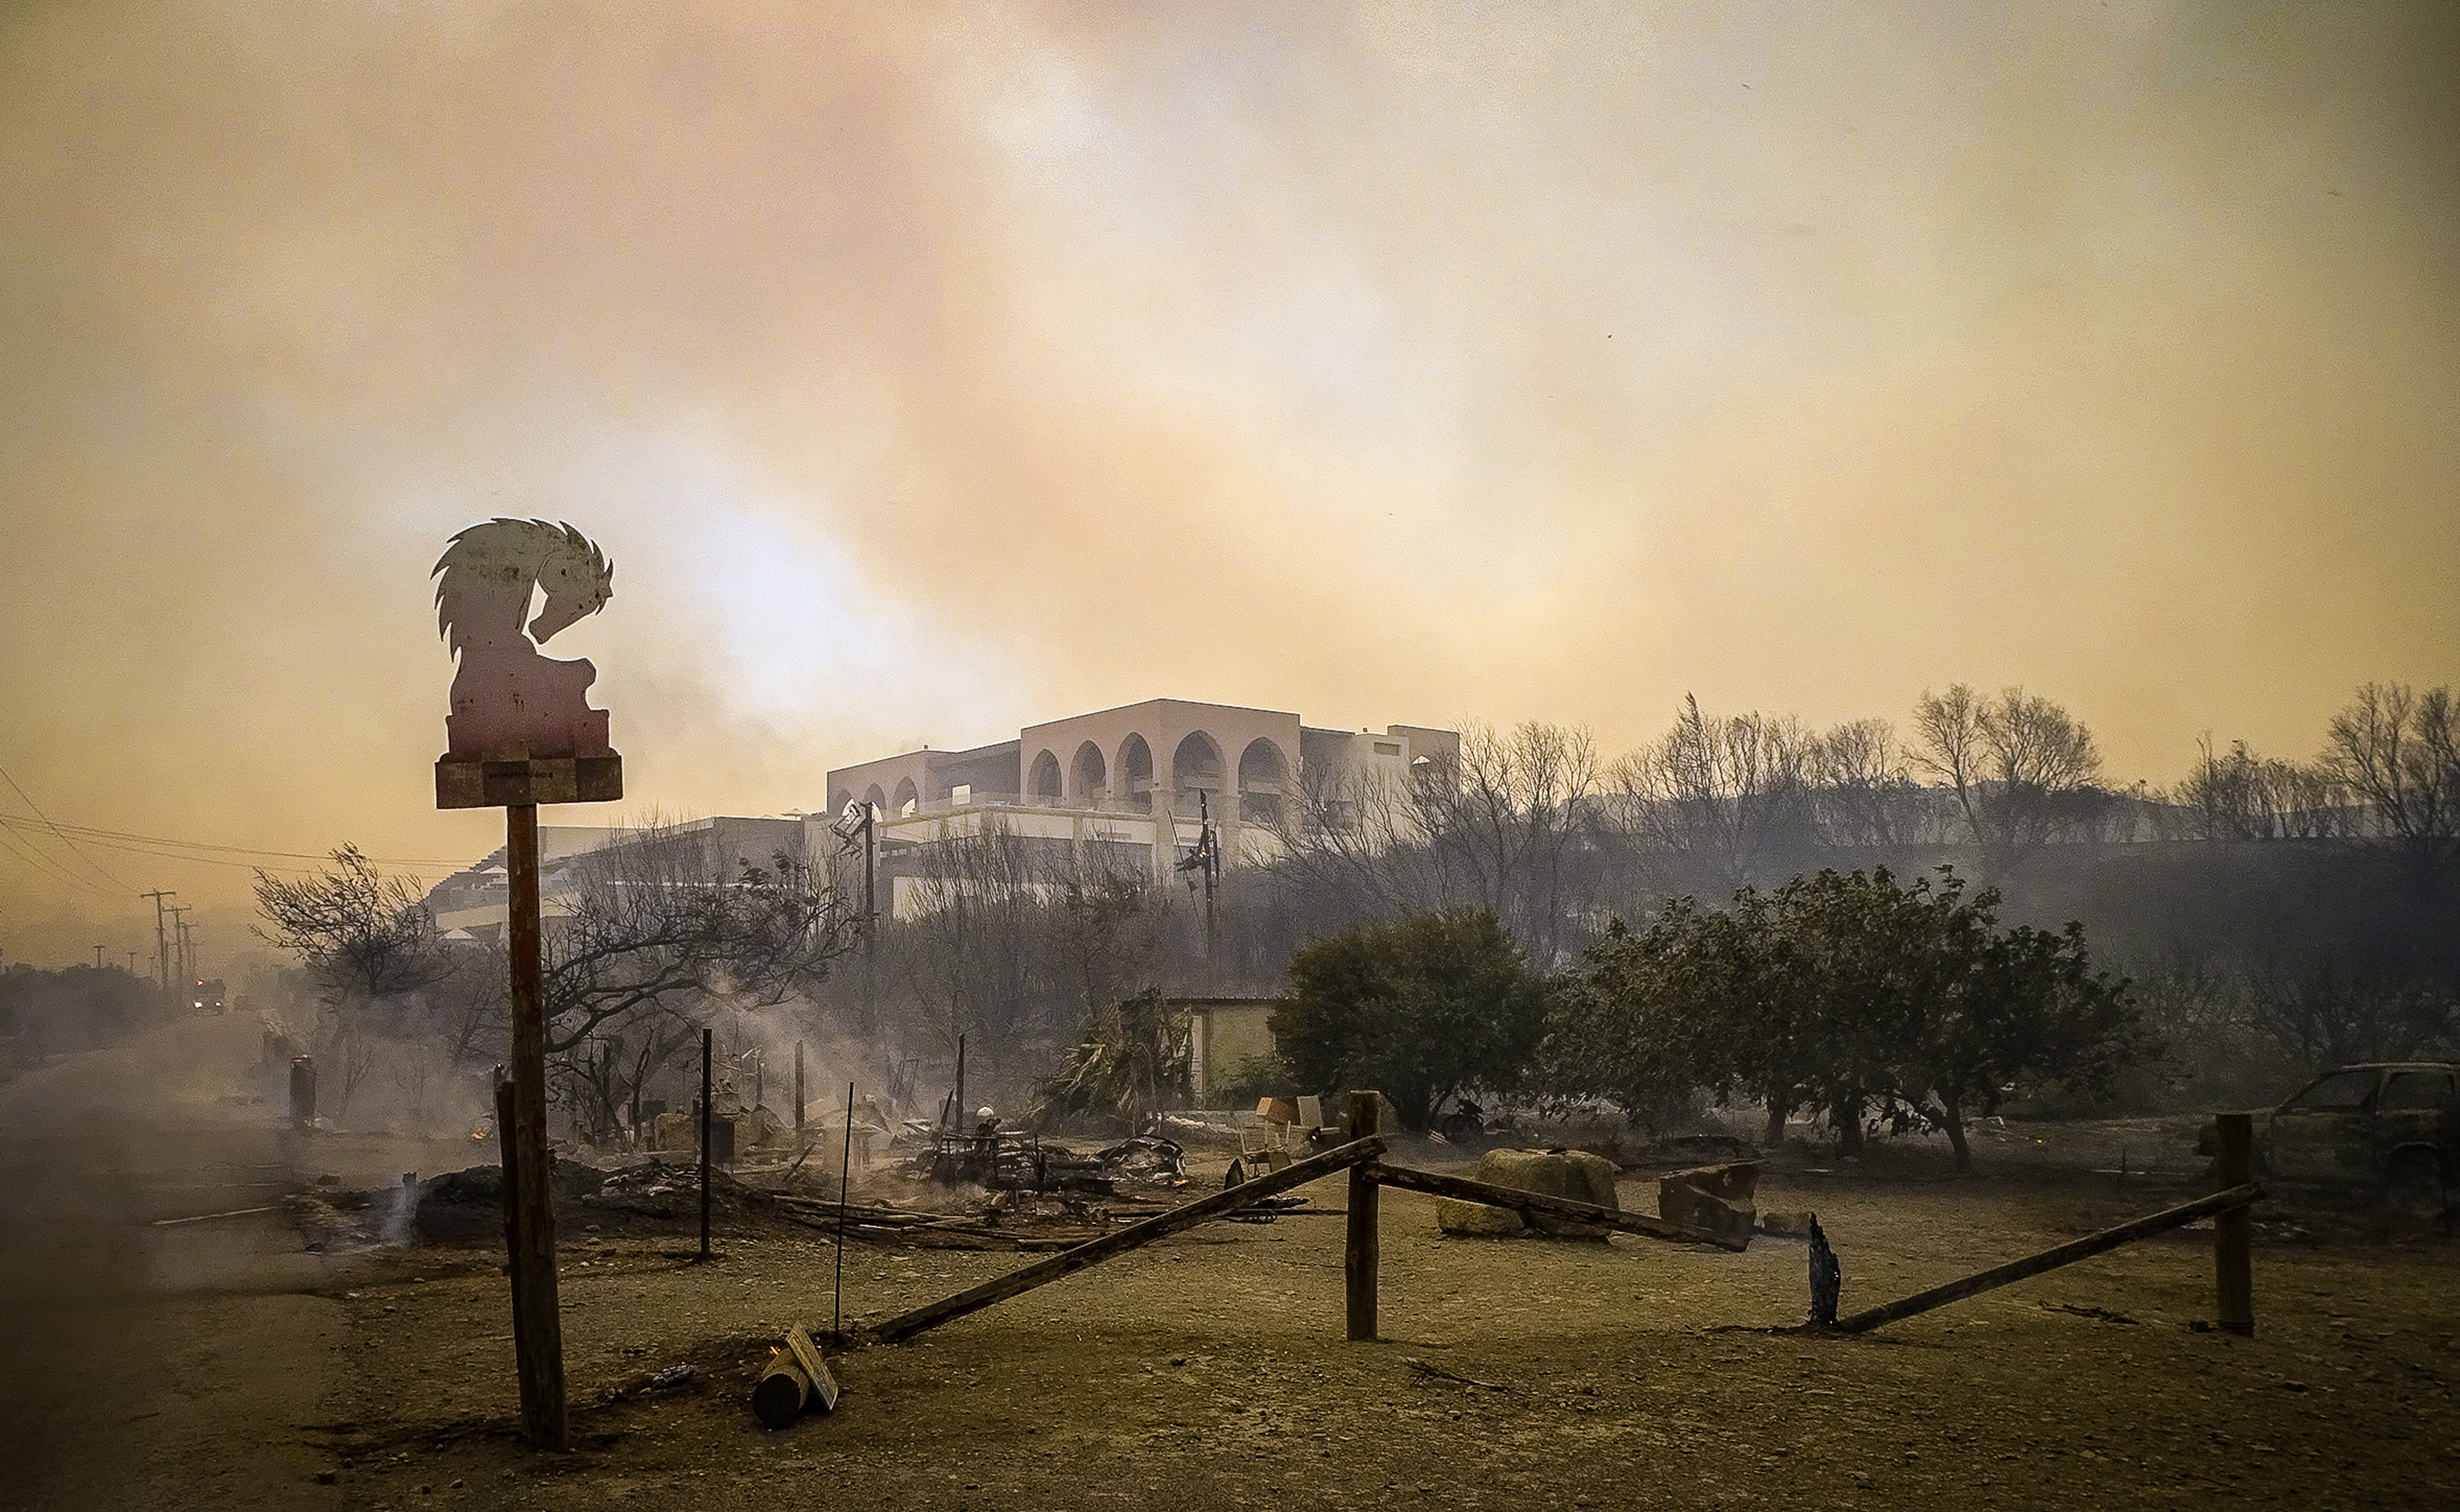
1914, 684, 2108, 873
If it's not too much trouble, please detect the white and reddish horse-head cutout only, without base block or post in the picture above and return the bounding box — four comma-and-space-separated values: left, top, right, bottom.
433, 519, 615, 762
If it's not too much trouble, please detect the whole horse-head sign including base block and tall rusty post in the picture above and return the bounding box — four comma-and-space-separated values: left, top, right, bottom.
433, 519, 622, 1451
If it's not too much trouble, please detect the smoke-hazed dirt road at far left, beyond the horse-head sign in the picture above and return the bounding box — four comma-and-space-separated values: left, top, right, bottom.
0, 1016, 347, 1510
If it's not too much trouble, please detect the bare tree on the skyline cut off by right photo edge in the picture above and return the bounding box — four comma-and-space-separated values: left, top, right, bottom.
2322, 684, 2460, 880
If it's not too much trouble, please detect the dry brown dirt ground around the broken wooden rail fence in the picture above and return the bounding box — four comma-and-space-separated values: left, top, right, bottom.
5, 1018, 2460, 1512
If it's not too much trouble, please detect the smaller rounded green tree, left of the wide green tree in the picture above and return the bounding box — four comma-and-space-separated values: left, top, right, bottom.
1272, 910, 1545, 1131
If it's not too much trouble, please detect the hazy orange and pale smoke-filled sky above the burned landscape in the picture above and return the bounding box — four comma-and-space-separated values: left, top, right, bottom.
0, 0, 2460, 959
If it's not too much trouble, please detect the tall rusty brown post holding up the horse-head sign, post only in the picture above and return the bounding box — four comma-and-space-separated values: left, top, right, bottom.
504, 804, 571, 1453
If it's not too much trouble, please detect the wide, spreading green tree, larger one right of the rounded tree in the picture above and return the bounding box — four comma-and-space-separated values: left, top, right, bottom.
1542, 868, 2157, 1168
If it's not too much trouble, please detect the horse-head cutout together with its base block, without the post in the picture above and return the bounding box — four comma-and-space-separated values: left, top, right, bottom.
433, 519, 622, 809
